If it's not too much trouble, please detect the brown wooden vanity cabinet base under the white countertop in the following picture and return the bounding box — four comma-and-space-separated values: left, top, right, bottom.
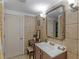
34, 42, 67, 59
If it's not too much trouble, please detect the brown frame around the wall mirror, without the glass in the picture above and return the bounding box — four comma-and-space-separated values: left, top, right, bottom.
46, 5, 66, 40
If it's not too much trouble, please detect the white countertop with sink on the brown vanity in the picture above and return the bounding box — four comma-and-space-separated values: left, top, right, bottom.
35, 42, 66, 58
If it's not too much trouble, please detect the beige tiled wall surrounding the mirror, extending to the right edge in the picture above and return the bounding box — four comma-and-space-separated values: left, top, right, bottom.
40, 2, 79, 59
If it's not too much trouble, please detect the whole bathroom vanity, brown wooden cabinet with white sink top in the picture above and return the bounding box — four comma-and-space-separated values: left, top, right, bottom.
35, 42, 67, 59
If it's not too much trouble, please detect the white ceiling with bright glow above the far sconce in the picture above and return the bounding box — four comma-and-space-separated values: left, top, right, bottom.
4, 0, 62, 15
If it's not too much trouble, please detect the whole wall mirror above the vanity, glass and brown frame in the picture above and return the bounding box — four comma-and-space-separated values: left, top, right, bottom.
46, 6, 65, 40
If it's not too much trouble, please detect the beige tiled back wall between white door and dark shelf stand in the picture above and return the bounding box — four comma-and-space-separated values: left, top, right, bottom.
24, 16, 36, 49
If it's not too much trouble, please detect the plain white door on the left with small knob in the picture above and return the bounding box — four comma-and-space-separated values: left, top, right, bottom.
4, 14, 24, 58
